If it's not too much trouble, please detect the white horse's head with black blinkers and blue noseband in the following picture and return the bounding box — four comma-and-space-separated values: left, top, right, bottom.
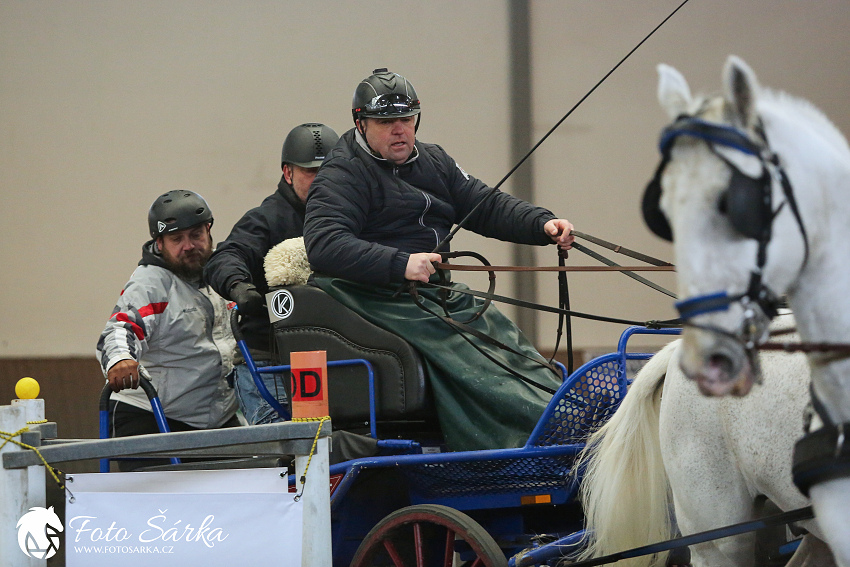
643, 56, 808, 395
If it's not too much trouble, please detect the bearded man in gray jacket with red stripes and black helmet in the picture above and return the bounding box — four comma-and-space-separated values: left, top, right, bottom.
97, 190, 239, 470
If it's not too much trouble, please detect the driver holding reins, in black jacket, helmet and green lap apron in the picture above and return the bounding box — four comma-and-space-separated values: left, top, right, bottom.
304, 69, 574, 450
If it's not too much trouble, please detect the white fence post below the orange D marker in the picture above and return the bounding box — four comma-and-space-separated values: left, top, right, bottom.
295, 437, 333, 567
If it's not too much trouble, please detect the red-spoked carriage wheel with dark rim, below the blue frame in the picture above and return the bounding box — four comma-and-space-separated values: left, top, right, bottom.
351, 504, 508, 567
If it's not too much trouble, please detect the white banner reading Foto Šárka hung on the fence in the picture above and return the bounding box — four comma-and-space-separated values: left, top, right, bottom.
64, 468, 302, 567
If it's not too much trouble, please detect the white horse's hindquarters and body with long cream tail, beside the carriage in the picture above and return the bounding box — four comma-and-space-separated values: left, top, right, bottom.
581, 332, 832, 567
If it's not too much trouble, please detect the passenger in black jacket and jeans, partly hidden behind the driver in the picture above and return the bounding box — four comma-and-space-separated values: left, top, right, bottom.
204, 124, 339, 425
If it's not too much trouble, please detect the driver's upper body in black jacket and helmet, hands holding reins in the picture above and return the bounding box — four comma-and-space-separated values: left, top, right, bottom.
304, 69, 574, 284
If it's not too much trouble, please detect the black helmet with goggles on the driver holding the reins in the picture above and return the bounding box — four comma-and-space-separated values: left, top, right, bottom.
351, 69, 419, 126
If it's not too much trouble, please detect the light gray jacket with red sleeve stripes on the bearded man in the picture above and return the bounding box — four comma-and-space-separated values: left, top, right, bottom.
97, 242, 236, 429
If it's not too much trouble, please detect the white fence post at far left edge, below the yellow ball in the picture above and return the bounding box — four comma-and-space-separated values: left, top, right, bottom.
0, 405, 38, 567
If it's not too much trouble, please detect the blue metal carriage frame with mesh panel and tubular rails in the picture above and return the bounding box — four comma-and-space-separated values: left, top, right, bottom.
245, 326, 681, 567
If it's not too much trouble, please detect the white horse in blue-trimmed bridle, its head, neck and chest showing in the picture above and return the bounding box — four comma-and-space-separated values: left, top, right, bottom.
644, 57, 850, 567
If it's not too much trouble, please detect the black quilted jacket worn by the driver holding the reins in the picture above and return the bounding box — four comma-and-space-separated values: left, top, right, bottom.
304, 129, 555, 284
